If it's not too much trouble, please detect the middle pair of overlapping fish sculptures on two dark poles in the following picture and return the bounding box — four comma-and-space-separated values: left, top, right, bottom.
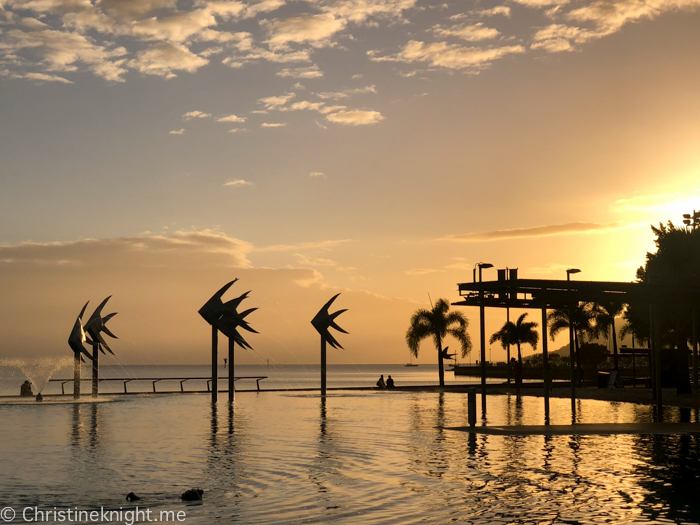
199, 279, 258, 403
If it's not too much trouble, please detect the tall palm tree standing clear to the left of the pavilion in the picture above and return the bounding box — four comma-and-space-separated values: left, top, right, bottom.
406, 299, 472, 386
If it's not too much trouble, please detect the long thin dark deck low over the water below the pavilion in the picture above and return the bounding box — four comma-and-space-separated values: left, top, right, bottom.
445, 423, 700, 436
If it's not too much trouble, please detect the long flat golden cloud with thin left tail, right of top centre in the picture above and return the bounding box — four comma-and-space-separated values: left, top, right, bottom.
368, 40, 525, 69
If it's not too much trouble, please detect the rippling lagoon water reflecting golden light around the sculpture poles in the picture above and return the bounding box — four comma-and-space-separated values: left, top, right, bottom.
0, 391, 700, 524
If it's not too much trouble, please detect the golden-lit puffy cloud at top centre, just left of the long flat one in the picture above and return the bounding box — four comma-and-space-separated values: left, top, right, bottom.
260, 13, 346, 49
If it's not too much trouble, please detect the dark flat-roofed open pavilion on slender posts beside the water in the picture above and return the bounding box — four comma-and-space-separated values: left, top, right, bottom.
452, 271, 700, 422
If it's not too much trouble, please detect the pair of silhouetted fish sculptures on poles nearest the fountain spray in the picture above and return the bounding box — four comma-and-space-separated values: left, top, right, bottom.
68, 295, 117, 398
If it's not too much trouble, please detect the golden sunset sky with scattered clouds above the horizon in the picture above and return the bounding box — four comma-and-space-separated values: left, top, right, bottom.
0, 0, 700, 364
